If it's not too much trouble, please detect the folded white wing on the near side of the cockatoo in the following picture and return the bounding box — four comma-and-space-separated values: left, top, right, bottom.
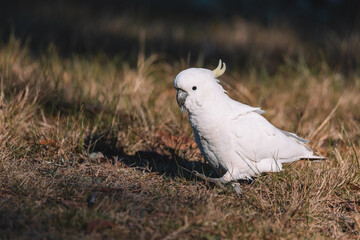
231, 106, 316, 163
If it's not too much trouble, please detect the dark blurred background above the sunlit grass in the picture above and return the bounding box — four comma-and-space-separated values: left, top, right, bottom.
0, 0, 360, 73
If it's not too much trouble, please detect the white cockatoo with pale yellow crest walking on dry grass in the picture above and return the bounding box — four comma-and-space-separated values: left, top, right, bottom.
174, 60, 324, 186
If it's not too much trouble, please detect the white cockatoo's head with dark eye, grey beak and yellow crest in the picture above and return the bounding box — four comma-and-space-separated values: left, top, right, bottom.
174, 60, 226, 113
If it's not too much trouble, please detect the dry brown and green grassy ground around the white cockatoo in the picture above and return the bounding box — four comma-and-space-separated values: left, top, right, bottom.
0, 38, 360, 239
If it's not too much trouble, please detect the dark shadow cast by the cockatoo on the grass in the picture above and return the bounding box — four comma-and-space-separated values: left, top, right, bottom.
84, 128, 218, 180
